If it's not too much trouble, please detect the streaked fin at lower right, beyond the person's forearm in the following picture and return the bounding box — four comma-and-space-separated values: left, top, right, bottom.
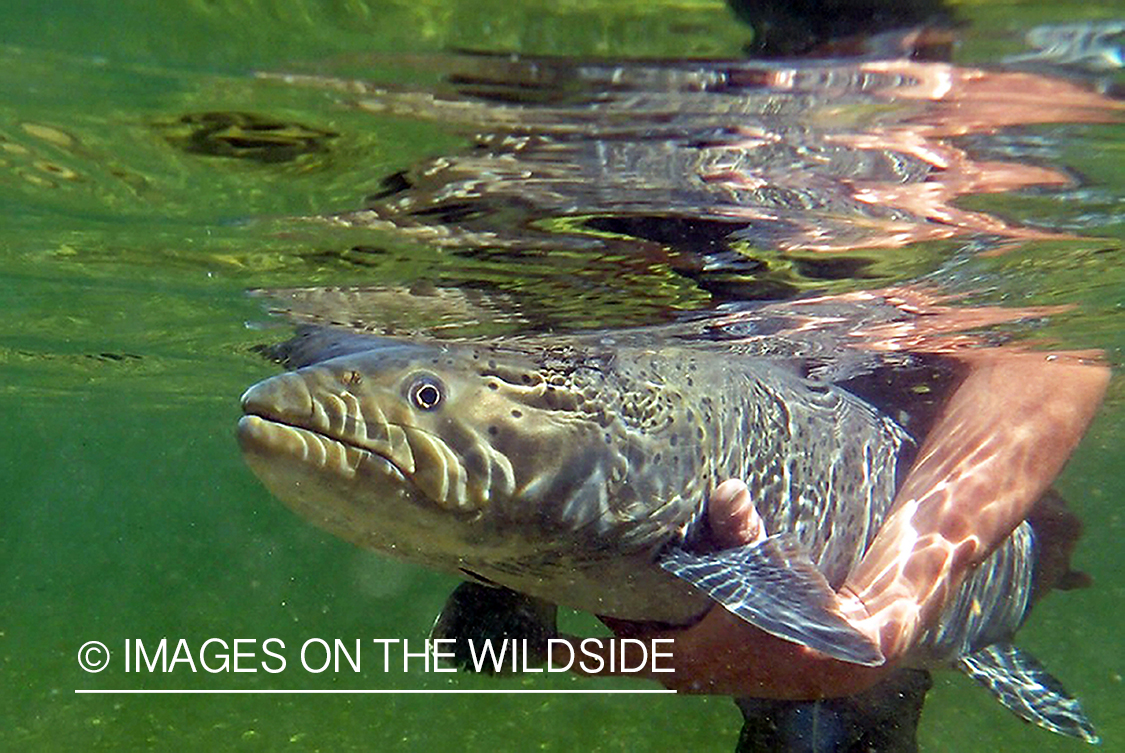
957, 643, 1099, 743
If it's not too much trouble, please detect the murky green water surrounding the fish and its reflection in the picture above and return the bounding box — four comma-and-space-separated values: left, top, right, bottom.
0, 0, 1125, 751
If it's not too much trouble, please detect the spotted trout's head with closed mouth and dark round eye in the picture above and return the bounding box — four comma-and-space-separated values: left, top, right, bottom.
239, 342, 652, 570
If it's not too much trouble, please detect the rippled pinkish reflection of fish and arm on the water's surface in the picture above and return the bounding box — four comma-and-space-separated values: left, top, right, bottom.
261, 51, 1125, 269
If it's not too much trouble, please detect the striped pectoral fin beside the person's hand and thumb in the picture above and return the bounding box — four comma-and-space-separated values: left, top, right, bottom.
659, 535, 885, 666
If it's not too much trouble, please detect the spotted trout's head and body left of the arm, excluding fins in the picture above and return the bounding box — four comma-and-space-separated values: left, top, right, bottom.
240, 330, 912, 624
